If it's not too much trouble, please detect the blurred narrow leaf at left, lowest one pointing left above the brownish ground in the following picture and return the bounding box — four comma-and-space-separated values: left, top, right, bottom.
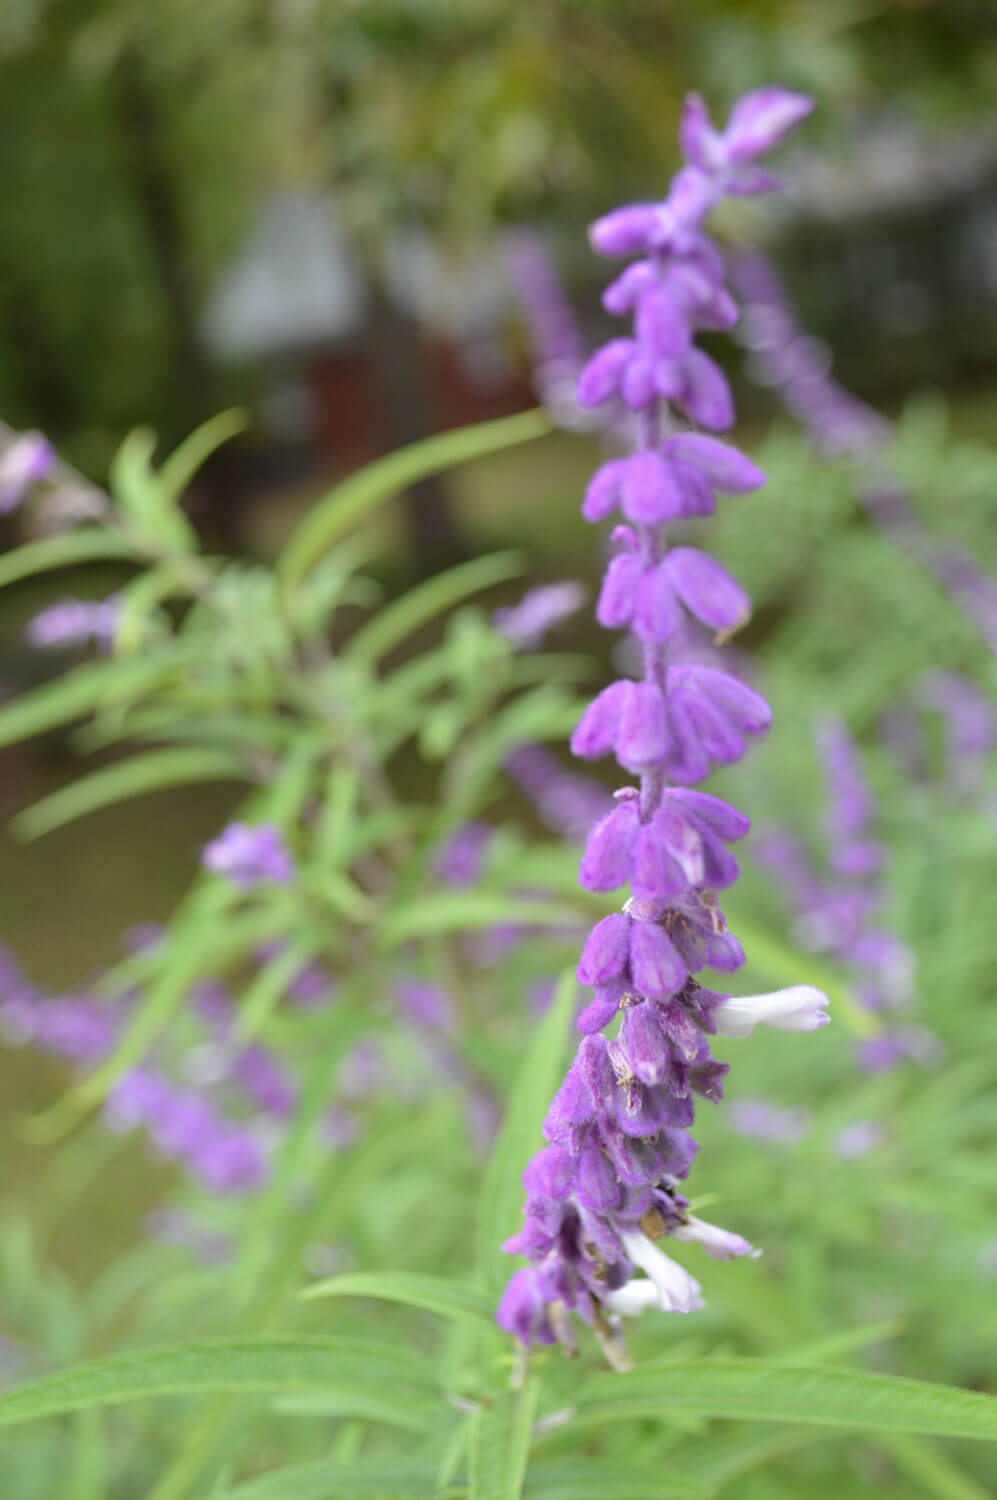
10, 749, 244, 840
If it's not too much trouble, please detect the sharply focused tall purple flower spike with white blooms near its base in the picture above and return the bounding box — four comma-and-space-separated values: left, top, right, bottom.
498, 89, 828, 1364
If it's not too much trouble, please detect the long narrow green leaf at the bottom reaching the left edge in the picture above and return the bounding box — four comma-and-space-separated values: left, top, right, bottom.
0, 1338, 433, 1427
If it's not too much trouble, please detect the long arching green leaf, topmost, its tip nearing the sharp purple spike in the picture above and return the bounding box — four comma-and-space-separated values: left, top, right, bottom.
277, 410, 550, 585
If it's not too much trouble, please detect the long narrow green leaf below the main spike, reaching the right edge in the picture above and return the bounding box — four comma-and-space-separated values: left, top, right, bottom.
577, 1359, 997, 1442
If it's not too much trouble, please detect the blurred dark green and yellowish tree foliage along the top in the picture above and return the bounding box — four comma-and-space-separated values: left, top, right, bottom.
0, 0, 997, 473
